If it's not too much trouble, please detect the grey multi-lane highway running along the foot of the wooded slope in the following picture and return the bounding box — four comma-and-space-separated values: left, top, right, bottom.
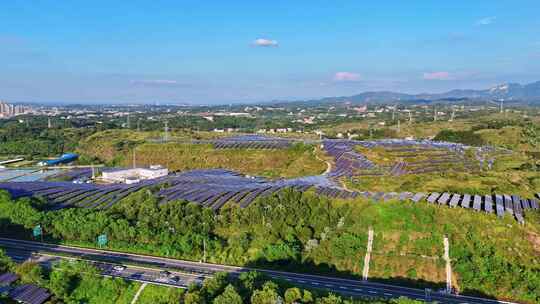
0, 238, 511, 304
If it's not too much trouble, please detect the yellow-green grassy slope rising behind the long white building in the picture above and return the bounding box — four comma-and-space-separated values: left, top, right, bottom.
79, 130, 326, 177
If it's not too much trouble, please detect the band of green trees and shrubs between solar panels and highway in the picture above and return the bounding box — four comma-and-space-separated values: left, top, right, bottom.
0, 190, 540, 303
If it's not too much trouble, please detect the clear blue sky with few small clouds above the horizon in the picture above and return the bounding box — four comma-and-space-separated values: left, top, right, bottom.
0, 0, 540, 104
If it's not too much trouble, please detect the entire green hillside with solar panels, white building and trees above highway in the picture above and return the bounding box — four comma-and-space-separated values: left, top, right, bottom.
0, 107, 540, 303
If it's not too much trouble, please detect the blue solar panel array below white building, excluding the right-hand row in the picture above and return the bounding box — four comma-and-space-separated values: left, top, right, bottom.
0, 169, 326, 210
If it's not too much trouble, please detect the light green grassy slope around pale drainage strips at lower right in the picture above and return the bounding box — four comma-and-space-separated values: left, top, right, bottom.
336, 197, 540, 299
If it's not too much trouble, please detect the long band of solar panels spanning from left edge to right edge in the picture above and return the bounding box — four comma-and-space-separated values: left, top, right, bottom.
0, 169, 540, 223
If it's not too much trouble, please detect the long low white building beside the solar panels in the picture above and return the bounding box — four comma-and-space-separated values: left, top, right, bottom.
101, 166, 169, 184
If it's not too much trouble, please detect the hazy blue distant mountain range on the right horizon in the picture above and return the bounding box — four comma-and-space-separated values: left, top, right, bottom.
302, 81, 540, 103
